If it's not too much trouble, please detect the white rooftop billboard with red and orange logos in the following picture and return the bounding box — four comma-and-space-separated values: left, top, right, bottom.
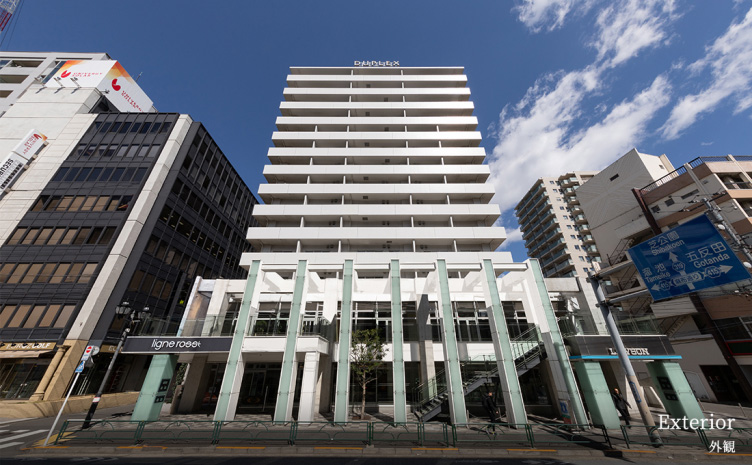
44, 60, 153, 112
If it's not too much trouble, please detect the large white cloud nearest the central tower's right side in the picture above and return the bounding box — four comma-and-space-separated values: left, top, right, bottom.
489, 74, 671, 211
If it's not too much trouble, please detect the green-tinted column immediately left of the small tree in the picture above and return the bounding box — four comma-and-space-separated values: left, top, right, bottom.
334, 260, 353, 423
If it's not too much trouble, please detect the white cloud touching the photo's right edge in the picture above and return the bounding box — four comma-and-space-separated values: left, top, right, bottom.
661, 9, 752, 139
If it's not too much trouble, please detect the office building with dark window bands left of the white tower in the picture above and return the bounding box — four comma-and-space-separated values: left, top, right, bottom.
0, 54, 256, 416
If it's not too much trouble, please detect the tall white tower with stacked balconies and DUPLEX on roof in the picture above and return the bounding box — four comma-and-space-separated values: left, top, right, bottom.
119, 62, 704, 426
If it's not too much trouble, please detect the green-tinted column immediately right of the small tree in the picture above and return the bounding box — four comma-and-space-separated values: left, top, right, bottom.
390, 260, 407, 423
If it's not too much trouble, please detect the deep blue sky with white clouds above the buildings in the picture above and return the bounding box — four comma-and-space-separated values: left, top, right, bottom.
2, 0, 752, 260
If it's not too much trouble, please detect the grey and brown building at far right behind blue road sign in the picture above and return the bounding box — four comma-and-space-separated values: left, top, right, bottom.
577, 150, 752, 402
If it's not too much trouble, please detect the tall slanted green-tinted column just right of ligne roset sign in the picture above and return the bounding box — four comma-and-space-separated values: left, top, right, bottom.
214, 260, 261, 421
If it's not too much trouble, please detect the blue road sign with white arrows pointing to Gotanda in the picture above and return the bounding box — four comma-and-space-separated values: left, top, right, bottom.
628, 215, 750, 300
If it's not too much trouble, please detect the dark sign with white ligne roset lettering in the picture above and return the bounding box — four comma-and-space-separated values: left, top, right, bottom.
123, 336, 232, 354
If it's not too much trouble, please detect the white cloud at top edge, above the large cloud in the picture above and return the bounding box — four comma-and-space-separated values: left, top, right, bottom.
591, 0, 676, 66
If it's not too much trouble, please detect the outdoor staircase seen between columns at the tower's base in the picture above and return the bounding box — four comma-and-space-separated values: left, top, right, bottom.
412, 326, 544, 422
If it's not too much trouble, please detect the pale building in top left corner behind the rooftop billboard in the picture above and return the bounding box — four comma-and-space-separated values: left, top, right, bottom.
0, 51, 110, 116
